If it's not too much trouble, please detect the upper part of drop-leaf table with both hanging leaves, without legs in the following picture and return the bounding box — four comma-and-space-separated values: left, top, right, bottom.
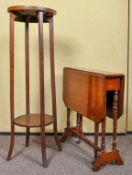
63, 68, 124, 122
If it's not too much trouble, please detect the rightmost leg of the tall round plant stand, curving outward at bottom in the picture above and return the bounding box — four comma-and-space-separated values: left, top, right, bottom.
49, 18, 61, 150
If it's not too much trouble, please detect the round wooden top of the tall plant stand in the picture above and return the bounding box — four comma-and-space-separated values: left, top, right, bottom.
7, 6, 56, 23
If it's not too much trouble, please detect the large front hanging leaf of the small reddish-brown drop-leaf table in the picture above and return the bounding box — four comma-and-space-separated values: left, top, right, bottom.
63, 68, 105, 122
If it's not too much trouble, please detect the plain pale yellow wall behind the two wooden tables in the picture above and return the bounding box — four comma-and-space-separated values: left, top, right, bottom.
0, 0, 127, 132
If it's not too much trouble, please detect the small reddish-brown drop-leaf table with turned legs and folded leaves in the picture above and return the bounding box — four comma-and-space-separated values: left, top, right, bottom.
61, 68, 124, 171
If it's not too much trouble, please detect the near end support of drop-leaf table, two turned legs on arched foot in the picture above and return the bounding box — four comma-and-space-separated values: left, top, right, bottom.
93, 91, 123, 171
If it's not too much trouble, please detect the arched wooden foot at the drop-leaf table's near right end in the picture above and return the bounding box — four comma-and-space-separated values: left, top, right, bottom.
93, 150, 124, 171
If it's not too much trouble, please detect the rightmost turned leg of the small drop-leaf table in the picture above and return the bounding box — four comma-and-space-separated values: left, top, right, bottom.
112, 91, 118, 150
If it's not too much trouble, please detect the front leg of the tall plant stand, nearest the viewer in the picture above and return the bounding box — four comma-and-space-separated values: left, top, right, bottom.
38, 11, 48, 167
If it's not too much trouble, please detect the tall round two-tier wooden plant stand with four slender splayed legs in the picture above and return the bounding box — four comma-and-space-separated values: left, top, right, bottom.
7, 6, 61, 167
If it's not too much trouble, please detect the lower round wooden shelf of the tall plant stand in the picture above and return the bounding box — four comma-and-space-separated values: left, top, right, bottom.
14, 114, 54, 127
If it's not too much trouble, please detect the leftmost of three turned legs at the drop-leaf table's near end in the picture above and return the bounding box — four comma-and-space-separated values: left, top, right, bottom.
94, 122, 99, 159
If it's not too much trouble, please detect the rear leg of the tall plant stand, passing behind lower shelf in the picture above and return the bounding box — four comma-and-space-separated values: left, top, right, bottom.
25, 19, 30, 146
